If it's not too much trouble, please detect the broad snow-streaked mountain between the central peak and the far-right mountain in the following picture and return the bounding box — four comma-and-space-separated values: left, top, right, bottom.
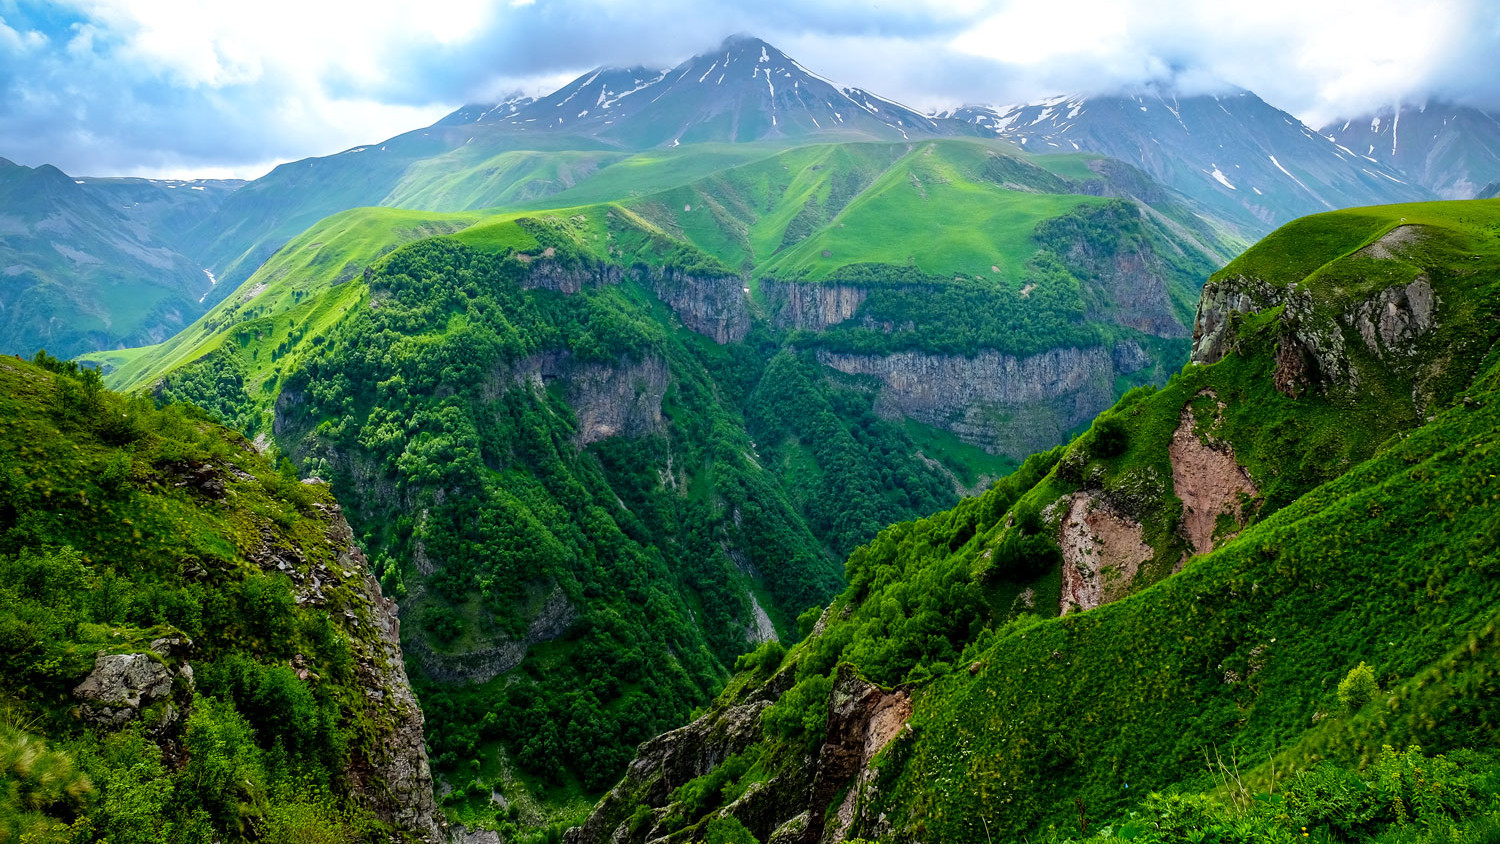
941, 90, 1433, 235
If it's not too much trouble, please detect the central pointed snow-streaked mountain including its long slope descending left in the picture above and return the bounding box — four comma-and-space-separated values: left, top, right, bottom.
172, 36, 948, 299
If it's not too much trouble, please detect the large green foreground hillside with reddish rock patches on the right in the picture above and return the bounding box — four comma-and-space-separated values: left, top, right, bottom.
569, 201, 1500, 843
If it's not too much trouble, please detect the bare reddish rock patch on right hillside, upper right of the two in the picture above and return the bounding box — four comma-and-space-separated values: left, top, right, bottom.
1167, 395, 1260, 553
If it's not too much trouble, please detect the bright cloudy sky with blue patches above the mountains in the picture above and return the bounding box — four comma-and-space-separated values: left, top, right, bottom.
0, 0, 1500, 178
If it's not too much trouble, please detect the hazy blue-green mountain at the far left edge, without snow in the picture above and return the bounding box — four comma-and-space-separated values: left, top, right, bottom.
0, 159, 237, 357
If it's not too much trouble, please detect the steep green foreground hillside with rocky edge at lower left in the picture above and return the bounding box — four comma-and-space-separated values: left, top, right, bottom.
0, 357, 440, 843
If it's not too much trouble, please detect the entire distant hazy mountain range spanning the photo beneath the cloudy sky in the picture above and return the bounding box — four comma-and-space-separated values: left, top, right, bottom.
0, 36, 1500, 354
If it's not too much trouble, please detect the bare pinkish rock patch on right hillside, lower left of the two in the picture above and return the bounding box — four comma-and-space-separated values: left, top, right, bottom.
1058, 493, 1157, 615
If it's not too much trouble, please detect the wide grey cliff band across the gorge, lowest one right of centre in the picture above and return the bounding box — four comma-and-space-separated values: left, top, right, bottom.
818, 342, 1149, 459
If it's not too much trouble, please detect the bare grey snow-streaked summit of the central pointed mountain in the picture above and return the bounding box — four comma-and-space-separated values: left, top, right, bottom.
444, 34, 951, 148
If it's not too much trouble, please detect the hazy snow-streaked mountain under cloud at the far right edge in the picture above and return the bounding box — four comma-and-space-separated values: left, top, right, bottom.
1320, 100, 1500, 199
